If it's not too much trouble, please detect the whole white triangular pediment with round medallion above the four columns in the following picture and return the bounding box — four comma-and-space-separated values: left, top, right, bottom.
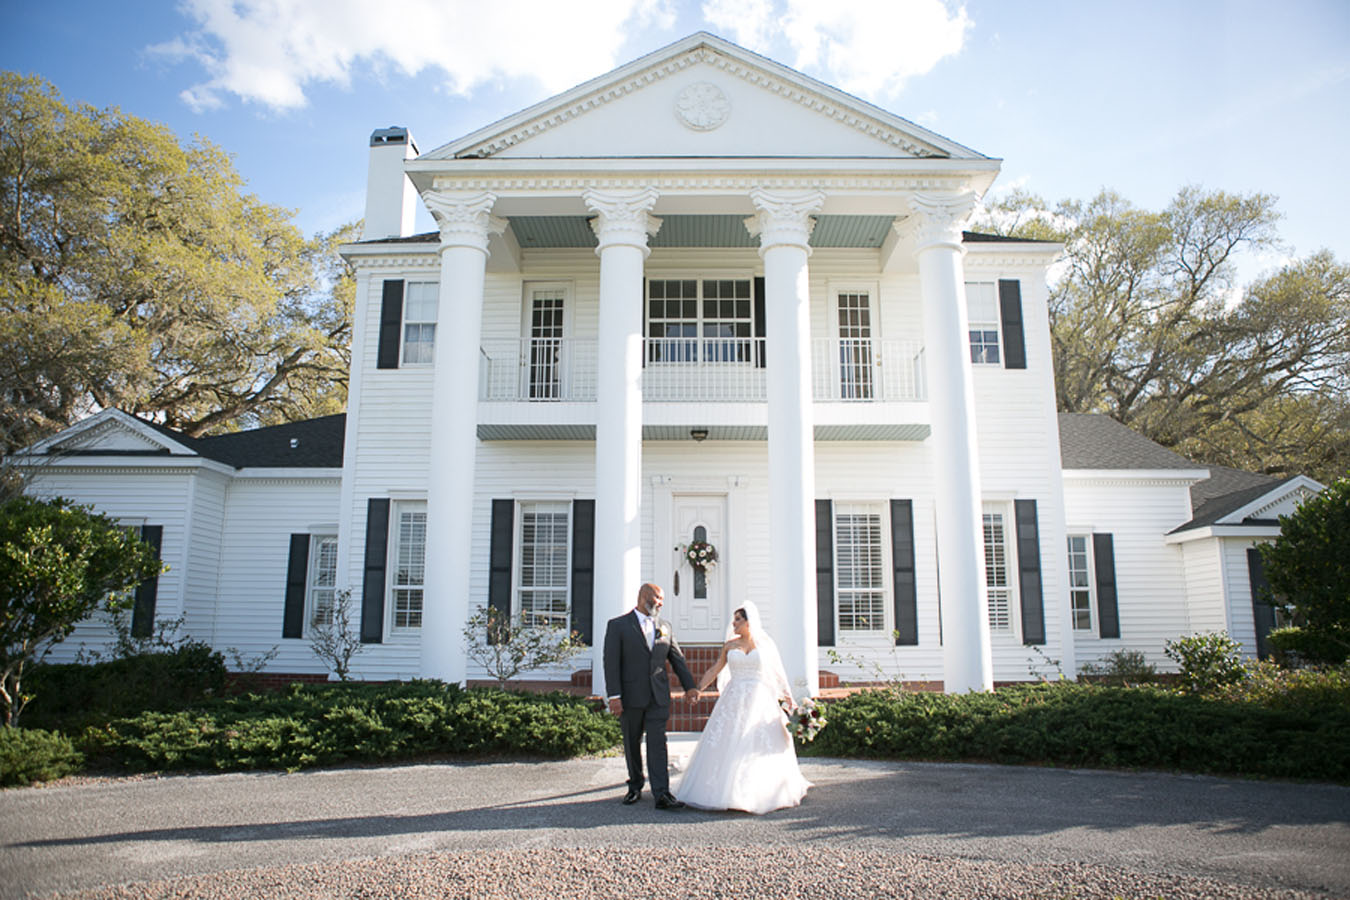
421, 32, 986, 161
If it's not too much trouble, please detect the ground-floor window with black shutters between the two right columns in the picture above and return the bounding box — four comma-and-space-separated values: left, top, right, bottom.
834, 503, 886, 634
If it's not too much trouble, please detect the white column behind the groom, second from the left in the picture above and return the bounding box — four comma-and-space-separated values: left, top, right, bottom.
582, 188, 662, 696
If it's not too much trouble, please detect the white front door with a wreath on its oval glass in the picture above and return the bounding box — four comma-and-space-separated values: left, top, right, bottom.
666, 494, 730, 644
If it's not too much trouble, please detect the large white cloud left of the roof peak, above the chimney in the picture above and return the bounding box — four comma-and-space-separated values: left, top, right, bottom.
151, 0, 658, 109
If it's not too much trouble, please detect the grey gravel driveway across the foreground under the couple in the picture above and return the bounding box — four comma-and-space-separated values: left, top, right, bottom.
0, 738, 1350, 900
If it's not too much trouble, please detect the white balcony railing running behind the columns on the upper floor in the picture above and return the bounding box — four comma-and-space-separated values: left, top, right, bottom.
479, 337, 927, 403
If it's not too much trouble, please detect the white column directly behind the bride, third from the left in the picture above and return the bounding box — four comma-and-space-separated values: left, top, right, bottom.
745, 188, 825, 698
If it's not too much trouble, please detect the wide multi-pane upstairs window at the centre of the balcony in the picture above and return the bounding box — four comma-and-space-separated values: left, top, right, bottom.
647, 278, 755, 363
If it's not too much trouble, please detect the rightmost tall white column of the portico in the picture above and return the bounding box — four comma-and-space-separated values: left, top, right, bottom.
910, 193, 994, 694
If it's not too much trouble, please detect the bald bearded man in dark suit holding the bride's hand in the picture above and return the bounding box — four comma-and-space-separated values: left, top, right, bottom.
605, 584, 698, 810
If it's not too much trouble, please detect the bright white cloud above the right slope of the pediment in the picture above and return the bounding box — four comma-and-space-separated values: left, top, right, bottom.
703, 0, 972, 97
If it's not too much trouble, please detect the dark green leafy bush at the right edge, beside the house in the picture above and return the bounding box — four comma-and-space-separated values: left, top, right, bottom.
1260, 476, 1350, 663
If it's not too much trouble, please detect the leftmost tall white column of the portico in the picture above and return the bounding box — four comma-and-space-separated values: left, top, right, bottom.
421, 192, 506, 684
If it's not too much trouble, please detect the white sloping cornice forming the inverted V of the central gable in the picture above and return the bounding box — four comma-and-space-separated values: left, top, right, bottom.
414, 31, 988, 161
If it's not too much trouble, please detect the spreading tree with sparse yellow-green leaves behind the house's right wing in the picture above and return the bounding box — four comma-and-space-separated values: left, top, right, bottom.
976, 188, 1350, 480
